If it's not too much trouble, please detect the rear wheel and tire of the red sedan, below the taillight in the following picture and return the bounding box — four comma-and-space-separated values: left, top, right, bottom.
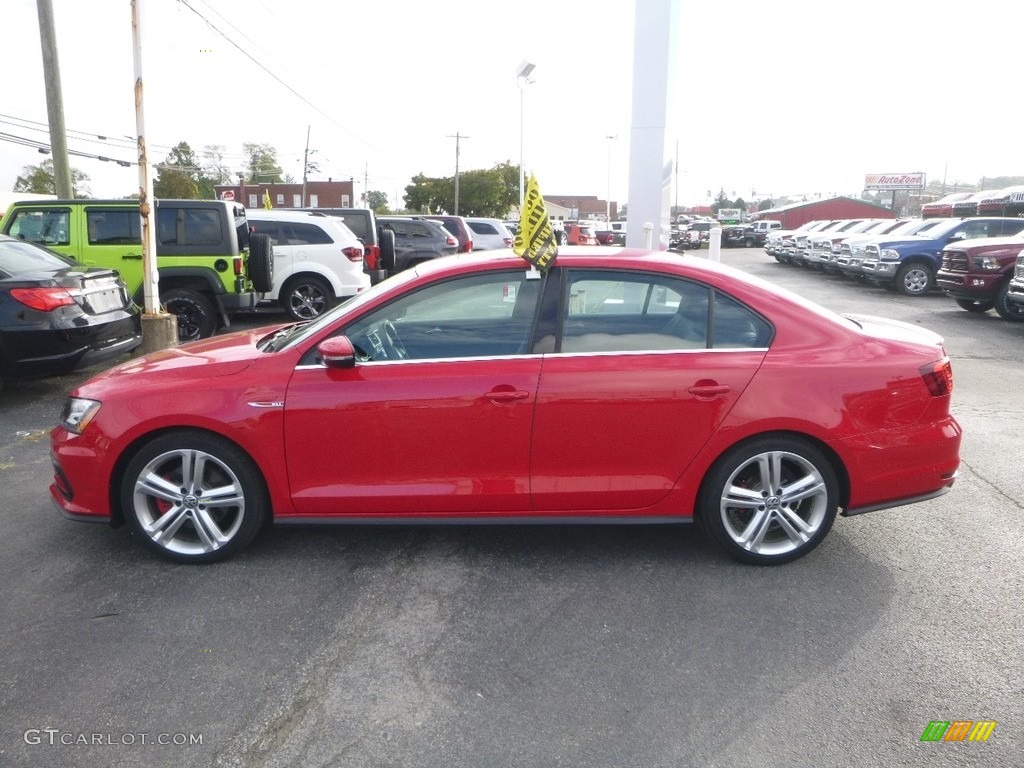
697, 435, 839, 565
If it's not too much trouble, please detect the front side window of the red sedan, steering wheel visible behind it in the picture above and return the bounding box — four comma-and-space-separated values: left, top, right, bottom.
343, 269, 542, 361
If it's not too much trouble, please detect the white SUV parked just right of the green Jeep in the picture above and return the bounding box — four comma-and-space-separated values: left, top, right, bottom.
246, 209, 370, 321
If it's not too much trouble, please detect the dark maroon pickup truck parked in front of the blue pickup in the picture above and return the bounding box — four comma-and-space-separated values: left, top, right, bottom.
935, 233, 1024, 322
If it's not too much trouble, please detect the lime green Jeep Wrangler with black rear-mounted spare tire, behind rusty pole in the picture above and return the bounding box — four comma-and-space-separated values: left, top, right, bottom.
0, 200, 273, 342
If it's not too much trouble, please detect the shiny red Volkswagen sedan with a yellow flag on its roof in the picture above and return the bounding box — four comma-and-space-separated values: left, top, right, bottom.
50, 248, 961, 564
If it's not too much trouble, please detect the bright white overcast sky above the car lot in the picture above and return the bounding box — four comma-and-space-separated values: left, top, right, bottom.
0, 0, 1024, 206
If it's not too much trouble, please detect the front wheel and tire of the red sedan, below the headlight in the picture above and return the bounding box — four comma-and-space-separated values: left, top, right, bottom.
120, 430, 269, 563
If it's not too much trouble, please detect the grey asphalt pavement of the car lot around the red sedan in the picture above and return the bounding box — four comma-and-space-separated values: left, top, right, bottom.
0, 249, 1024, 766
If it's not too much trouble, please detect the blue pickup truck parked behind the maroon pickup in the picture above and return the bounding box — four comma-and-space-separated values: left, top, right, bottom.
861, 217, 1024, 296
